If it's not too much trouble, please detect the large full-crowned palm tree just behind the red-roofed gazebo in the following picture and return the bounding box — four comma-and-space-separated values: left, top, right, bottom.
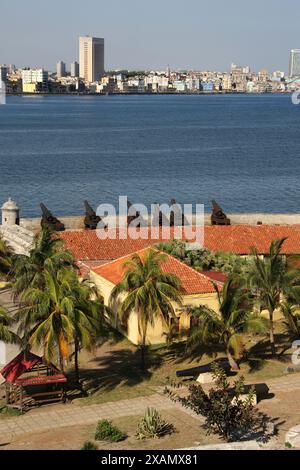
17, 269, 105, 382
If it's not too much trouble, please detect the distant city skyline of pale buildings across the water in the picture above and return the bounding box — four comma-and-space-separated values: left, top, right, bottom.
0, 36, 300, 94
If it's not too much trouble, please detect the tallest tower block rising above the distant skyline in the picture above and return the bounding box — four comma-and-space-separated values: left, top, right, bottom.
79, 36, 104, 82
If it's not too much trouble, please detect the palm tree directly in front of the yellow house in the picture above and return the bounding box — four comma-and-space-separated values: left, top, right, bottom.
110, 249, 181, 368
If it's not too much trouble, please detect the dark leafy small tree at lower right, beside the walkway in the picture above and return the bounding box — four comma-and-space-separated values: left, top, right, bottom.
175, 365, 257, 442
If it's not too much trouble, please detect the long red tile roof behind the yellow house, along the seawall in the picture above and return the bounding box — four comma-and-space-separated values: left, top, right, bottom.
59, 225, 300, 264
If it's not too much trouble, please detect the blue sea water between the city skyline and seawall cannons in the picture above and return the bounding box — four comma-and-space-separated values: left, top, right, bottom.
0, 95, 300, 217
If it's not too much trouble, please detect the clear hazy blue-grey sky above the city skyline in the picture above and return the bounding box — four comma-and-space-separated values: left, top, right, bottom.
0, 0, 300, 72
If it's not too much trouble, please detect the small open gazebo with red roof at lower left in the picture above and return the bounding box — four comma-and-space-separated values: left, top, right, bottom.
0, 351, 67, 410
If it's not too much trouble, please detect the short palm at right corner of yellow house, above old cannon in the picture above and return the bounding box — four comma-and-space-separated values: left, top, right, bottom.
188, 278, 266, 370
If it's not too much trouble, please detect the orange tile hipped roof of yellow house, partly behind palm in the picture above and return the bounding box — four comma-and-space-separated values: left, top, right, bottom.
92, 248, 221, 295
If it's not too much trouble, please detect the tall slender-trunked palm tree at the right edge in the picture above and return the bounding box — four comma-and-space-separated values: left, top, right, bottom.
247, 238, 300, 356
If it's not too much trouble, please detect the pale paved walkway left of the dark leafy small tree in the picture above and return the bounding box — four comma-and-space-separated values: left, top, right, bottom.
0, 394, 190, 444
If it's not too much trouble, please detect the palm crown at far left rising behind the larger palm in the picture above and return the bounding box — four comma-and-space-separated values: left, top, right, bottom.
10, 229, 75, 297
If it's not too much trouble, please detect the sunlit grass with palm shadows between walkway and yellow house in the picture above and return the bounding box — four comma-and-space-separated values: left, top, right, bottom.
74, 328, 291, 405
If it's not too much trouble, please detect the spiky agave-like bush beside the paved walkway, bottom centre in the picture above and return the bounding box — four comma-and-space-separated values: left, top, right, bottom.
136, 408, 175, 439
